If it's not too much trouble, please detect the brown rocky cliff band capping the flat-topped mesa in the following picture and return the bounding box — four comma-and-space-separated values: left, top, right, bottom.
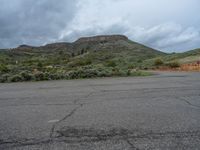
75, 35, 128, 43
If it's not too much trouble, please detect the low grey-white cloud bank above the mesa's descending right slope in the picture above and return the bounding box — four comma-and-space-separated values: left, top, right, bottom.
128, 23, 200, 52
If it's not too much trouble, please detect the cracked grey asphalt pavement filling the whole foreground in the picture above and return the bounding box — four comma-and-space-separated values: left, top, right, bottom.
0, 72, 200, 150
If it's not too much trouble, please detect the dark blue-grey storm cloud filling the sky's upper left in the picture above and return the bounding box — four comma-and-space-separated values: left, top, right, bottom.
0, 0, 76, 47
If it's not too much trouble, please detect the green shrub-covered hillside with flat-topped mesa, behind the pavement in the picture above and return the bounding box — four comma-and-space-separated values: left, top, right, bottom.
0, 35, 200, 82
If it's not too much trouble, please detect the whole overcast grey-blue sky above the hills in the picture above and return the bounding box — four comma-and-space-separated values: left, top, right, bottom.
0, 0, 200, 52
